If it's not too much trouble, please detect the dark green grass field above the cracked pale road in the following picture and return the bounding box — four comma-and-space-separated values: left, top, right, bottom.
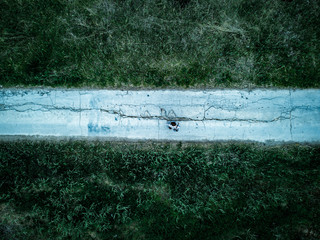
0, 0, 320, 88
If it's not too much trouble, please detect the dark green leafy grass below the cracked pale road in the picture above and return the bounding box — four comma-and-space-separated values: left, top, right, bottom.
0, 141, 320, 240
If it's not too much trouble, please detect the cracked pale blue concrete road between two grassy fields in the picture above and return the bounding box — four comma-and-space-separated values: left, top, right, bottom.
0, 89, 320, 142
